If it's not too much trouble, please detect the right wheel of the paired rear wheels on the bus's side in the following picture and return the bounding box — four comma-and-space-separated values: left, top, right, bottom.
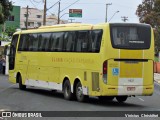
76, 82, 88, 102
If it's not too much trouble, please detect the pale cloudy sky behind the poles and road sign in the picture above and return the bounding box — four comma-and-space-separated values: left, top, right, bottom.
10, 0, 142, 24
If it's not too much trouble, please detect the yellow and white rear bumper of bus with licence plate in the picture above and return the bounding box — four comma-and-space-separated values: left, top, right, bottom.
101, 85, 154, 96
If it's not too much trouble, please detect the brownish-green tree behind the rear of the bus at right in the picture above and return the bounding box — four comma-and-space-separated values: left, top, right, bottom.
136, 0, 160, 54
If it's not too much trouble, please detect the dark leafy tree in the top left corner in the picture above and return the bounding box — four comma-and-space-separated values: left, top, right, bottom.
0, 0, 13, 24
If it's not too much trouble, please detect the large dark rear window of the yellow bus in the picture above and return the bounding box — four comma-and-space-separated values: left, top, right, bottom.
110, 24, 151, 49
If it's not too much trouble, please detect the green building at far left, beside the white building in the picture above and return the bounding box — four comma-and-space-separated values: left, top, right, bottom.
1, 6, 20, 31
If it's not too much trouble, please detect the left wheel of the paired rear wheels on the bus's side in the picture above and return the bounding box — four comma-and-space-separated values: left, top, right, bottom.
63, 80, 73, 100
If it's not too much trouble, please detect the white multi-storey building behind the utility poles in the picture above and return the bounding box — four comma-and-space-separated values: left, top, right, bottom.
20, 8, 67, 29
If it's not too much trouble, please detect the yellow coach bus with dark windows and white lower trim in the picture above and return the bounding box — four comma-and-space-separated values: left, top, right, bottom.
9, 23, 154, 102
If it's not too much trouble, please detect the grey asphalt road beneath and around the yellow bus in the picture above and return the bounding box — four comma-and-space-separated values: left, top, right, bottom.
0, 75, 160, 120
